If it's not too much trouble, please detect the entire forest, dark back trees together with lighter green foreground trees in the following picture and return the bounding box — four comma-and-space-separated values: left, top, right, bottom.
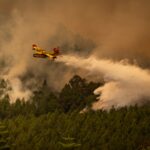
0, 75, 150, 150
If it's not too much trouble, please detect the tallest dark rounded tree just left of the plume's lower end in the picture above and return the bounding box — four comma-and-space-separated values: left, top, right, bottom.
59, 75, 100, 112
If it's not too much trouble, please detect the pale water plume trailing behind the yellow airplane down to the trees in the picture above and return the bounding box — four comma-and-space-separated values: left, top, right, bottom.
58, 55, 150, 109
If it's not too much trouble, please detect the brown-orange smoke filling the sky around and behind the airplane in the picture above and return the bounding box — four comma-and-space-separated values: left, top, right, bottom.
0, 0, 150, 100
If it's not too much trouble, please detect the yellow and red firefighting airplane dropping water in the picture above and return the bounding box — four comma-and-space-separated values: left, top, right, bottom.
32, 44, 60, 60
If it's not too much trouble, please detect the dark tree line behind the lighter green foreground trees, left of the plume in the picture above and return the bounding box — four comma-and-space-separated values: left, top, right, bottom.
0, 75, 100, 119
